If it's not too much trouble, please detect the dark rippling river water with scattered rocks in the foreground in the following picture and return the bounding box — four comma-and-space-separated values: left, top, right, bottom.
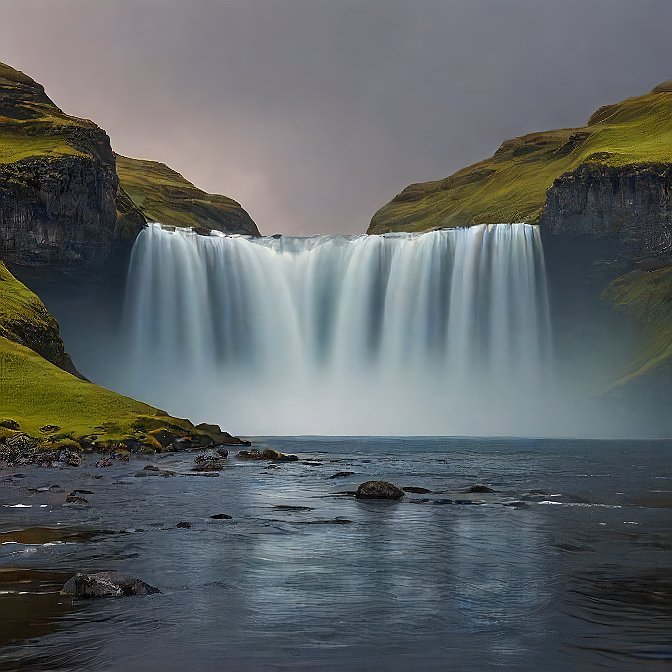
0, 437, 672, 672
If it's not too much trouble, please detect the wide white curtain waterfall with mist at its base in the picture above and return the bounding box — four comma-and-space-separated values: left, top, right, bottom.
122, 224, 550, 435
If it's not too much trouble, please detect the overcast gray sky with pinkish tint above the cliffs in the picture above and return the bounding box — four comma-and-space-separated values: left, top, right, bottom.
0, 0, 672, 234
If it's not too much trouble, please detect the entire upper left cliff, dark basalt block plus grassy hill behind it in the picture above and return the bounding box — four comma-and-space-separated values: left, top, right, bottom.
0, 59, 259, 277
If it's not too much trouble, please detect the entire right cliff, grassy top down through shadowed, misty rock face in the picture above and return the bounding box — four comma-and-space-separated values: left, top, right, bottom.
368, 81, 672, 389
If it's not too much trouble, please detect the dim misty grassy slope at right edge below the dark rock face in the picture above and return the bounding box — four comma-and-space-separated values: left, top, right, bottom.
603, 266, 672, 382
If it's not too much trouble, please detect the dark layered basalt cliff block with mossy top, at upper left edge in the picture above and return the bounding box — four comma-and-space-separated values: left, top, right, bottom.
0, 64, 144, 278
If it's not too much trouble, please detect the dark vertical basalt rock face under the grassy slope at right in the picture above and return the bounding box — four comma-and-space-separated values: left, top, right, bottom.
539, 163, 672, 260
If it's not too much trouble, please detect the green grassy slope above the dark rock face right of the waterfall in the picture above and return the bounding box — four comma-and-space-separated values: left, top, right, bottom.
368, 80, 672, 233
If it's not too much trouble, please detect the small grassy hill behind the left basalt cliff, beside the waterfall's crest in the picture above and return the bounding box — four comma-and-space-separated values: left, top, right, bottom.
116, 154, 259, 236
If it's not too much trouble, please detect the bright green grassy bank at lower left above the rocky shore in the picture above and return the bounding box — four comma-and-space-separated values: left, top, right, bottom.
0, 262, 242, 450
